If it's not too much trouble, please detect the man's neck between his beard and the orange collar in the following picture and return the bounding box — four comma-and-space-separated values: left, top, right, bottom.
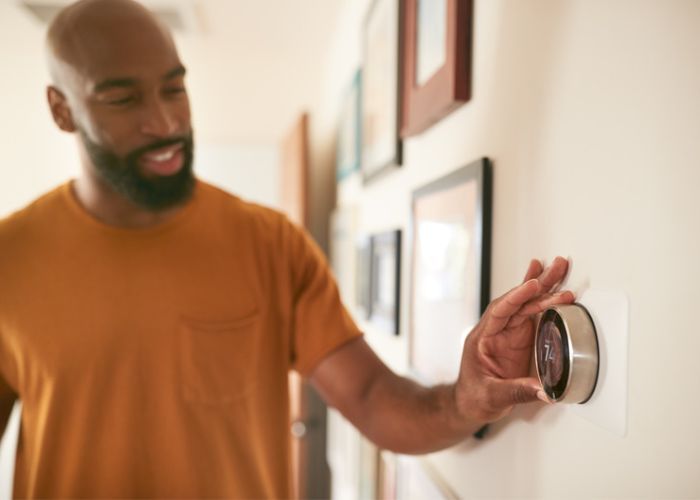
71, 173, 187, 229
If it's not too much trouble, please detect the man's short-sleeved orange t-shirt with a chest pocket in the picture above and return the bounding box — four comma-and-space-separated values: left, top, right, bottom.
0, 181, 361, 498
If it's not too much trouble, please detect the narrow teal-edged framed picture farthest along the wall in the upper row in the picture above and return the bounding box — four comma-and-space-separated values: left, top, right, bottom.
336, 70, 362, 182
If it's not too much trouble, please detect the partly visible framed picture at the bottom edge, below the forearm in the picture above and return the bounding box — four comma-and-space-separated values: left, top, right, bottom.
396, 455, 459, 500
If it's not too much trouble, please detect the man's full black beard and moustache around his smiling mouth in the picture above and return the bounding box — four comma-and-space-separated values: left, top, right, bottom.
80, 130, 195, 212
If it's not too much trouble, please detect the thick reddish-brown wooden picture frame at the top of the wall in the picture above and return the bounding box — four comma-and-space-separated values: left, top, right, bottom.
401, 0, 474, 138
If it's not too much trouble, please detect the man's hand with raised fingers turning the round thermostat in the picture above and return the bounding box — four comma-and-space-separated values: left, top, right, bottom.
454, 257, 575, 423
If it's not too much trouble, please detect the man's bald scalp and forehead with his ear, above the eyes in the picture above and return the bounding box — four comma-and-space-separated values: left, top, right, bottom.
47, 0, 190, 136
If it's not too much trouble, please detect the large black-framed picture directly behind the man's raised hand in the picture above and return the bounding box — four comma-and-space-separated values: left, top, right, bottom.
409, 158, 491, 384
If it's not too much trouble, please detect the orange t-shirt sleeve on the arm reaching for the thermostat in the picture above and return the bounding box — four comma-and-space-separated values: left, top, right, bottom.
288, 217, 362, 376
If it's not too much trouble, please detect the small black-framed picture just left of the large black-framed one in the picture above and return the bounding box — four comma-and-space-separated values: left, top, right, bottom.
369, 229, 401, 335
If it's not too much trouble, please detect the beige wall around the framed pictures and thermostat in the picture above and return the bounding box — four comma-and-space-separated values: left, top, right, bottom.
312, 0, 700, 498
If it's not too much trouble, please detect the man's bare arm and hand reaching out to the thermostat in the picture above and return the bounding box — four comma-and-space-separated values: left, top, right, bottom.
311, 258, 574, 453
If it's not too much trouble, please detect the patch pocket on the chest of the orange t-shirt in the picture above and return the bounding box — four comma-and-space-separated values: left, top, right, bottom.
180, 311, 261, 405
